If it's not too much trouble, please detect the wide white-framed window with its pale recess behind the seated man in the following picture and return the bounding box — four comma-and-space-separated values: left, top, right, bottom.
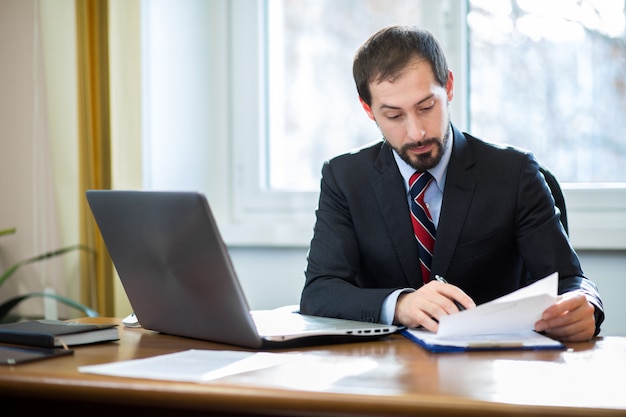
142, 0, 626, 249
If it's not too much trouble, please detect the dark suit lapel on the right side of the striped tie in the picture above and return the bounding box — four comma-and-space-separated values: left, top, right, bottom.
432, 126, 476, 277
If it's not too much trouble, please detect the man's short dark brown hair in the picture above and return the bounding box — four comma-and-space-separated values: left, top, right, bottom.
352, 26, 448, 105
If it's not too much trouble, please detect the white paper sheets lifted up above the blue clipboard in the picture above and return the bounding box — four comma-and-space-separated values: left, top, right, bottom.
437, 272, 558, 338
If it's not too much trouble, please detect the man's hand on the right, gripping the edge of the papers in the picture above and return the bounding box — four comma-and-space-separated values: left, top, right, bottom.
535, 291, 596, 342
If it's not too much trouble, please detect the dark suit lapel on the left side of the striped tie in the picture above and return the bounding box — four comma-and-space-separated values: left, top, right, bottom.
372, 143, 422, 288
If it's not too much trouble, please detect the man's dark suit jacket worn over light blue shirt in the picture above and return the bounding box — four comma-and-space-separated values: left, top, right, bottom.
300, 126, 604, 331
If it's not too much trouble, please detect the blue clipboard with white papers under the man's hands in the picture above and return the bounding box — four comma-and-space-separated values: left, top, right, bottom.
402, 272, 565, 352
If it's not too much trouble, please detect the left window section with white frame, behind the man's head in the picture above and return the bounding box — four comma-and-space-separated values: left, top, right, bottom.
226, 0, 464, 246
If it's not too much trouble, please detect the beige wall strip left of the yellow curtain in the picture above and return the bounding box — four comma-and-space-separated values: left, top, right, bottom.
0, 0, 77, 315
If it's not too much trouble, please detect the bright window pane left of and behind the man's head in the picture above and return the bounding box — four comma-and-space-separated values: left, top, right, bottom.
265, 0, 420, 191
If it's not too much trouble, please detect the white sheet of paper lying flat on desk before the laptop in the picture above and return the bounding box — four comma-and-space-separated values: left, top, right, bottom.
78, 349, 297, 382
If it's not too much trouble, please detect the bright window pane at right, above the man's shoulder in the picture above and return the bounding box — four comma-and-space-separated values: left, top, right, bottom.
468, 0, 626, 182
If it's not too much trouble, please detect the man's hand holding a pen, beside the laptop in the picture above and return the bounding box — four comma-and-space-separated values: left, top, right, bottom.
394, 280, 476, 332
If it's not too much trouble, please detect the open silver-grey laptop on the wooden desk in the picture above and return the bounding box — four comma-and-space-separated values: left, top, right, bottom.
86, 190, 398, 348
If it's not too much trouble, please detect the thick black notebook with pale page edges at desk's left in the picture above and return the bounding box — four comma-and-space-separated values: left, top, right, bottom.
0, 320, 119, 348
